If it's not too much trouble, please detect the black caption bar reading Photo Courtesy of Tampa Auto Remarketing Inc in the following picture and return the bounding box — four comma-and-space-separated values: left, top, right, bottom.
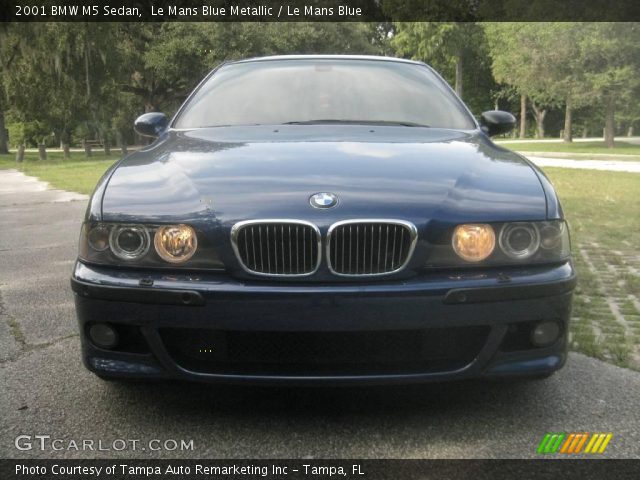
0, 460, 640, 480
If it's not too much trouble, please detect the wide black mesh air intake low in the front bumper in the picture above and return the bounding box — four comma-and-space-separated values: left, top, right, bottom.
160, 326, 490, 375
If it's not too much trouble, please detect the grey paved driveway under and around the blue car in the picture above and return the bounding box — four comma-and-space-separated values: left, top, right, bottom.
0, 171, 640, 458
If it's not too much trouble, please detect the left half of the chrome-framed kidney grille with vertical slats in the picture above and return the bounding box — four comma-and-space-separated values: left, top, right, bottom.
231, 220, 321, 276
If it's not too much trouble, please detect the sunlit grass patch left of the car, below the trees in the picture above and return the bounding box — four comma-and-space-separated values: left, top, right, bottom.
0, 152, 120, 194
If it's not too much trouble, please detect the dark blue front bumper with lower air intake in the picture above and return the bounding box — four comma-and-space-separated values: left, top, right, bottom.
71, 262, 576, 384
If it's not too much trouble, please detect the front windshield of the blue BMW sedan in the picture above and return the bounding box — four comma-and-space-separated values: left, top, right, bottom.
174, 59, 475, 129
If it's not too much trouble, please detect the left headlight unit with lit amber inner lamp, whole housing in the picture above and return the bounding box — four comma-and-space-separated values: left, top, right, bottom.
78, 222, 224, 270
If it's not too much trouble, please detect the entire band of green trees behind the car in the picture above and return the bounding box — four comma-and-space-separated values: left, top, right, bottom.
0, 22, 640, 153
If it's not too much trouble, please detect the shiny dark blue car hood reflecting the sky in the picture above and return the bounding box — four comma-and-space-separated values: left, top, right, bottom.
102, 125, 546, 226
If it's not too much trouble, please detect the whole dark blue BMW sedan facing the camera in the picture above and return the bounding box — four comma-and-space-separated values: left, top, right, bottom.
71, 56, 576, 384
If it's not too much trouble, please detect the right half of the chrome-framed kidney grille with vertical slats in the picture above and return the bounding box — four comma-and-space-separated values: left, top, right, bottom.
327, 220, 417, 276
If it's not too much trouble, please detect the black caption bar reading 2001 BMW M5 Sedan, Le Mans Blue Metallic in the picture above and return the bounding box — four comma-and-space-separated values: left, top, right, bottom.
0, 0, 640, 22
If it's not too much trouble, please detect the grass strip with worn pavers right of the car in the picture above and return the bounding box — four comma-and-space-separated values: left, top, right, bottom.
545, 168, 640, 370
